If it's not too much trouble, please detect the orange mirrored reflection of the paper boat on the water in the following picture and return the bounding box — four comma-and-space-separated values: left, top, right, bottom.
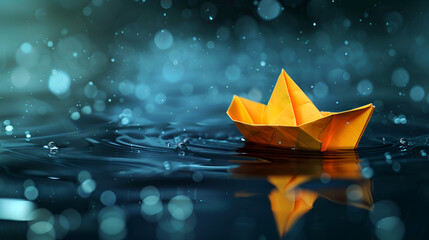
231, 147, 373, 237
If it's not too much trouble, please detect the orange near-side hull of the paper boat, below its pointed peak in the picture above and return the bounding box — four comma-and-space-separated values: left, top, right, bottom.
229, 104, 374, 151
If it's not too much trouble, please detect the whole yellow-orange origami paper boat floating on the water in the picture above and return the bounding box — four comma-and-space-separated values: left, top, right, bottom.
227, 70, 374, 151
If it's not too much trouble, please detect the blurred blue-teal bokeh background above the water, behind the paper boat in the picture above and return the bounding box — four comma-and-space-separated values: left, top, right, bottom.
0, 0, 429, 132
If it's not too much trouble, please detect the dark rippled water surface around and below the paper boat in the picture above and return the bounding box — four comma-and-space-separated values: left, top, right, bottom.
0, 117, 429, 239
